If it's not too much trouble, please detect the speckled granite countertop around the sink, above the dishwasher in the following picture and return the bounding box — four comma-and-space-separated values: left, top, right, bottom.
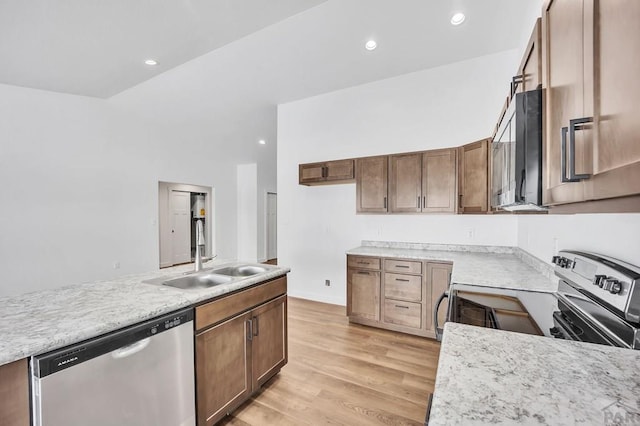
0, 260, 290, 365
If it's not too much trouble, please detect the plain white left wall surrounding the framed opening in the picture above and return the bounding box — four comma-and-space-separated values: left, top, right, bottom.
0, 85, 275, 296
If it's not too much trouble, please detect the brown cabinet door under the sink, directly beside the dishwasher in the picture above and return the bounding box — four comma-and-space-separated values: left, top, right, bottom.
196, 312, 251, 425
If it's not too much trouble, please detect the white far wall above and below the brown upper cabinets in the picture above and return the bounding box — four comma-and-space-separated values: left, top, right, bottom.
278, 51, 519, 304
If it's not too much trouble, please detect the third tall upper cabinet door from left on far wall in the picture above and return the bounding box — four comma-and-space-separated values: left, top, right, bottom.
422, 148, 457, 213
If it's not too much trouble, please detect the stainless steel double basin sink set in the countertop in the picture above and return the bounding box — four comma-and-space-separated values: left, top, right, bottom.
147, 265, 270, 290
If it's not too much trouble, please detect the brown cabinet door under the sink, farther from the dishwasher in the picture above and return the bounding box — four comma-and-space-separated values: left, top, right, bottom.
251, 296, 287, 390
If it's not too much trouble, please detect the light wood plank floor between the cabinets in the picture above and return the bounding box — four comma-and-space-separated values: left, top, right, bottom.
221, 298, 440, 426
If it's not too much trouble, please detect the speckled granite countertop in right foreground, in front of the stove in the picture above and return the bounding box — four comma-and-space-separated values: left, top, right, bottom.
429, 323, 640, 426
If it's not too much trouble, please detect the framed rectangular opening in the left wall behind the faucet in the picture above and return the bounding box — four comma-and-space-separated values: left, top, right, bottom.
158, 181, 215, 268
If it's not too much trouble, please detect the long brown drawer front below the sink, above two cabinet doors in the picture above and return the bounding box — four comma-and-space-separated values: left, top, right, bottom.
196, 276, 287, 330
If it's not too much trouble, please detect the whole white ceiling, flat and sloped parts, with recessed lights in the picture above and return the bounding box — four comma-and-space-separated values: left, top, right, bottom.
0, 0, 542, 161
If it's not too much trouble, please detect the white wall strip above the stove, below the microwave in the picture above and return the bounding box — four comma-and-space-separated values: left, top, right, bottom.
518, 213, 640, 265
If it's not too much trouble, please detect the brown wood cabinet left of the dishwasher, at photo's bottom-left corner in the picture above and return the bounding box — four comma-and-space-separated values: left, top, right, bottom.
0, 359, 31, 426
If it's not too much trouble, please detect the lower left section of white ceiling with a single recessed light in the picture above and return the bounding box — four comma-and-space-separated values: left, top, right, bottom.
0, 0, 325, 98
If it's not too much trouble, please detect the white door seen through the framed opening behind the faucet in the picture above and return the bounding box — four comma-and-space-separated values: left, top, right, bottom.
170, 191, 191, 265
